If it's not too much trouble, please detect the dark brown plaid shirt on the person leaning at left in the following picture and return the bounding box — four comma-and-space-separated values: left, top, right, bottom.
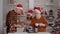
6, 10, 17, 26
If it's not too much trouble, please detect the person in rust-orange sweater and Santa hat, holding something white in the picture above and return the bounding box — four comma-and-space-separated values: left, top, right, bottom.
30, 7, 48, 32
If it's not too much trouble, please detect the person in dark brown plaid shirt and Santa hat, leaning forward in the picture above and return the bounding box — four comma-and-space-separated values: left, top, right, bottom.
6, 4, 23, 33
